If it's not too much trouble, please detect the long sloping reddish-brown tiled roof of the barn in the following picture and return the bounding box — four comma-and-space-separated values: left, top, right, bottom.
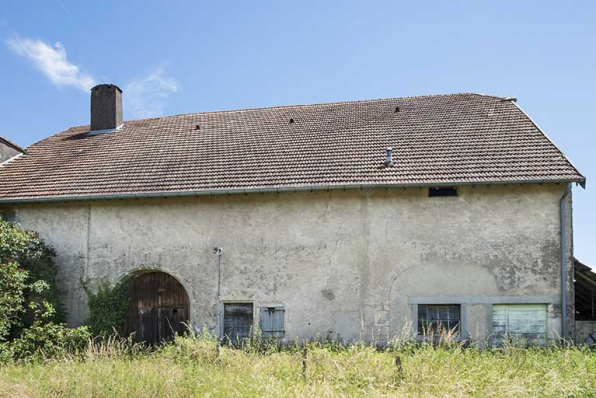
0, 94, 585, 201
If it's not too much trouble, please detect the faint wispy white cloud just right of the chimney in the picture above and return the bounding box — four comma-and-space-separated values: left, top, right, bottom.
124, 68, 180, 119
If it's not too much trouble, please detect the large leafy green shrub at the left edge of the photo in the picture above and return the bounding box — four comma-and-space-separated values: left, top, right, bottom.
0, 221, 91, 363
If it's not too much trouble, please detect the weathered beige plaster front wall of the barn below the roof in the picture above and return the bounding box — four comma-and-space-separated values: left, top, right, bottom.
10, 184, 573, 342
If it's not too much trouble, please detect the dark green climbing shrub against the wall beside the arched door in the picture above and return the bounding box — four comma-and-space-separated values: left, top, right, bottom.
83, 282, 129, 337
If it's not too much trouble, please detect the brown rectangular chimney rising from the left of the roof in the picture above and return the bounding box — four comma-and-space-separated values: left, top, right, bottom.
91, 84, 122, 132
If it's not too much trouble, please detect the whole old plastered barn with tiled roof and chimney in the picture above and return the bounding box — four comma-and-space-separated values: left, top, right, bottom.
0, 85, 585, 344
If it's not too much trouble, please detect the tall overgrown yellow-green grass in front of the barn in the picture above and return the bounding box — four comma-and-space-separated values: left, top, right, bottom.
0, 334, 596, 398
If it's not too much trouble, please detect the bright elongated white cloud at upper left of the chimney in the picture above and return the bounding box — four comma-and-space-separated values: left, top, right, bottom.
7, 38, 95, 92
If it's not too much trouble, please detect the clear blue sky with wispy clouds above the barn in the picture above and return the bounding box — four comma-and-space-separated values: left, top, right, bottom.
0, 0, 596, 265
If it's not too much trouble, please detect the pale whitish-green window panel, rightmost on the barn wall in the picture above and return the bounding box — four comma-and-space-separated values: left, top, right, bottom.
493, 304, 547, 344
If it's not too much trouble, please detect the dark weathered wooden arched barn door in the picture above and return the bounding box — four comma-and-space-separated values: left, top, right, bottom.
126, 271, 190, 344
